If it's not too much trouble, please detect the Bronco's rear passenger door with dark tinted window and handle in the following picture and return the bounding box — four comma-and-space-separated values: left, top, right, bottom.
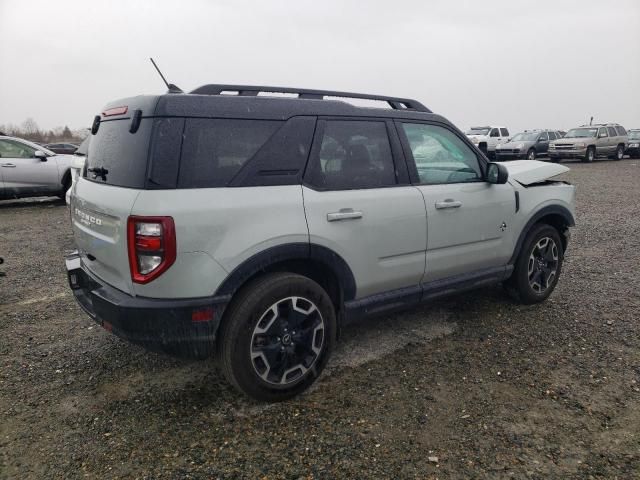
303, 118, 427, 298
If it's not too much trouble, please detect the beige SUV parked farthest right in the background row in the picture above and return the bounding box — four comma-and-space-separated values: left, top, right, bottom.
549, 123, 628, 162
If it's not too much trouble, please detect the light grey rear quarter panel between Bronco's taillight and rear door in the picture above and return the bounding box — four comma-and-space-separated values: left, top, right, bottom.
131, 185, 309, 298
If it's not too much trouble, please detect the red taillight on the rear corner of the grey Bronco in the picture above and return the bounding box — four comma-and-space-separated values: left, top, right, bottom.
127, 216, 176, 283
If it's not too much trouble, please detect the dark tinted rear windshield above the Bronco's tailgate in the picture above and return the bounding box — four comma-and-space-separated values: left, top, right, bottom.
84, 118, 153, 188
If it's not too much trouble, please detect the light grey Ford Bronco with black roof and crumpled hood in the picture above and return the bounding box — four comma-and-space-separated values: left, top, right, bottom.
66, 85, 575, 401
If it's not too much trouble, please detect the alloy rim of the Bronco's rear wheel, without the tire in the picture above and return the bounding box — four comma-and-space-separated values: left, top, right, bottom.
249, 297, 325, 385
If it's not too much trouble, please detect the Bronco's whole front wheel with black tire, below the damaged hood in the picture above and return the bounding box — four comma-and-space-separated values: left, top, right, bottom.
504, 224, 564, 305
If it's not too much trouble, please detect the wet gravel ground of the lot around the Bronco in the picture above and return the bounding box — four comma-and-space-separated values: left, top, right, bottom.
0, 159, 640, 479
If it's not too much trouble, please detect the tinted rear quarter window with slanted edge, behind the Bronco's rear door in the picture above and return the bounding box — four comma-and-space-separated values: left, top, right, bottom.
178, 119, 282, 188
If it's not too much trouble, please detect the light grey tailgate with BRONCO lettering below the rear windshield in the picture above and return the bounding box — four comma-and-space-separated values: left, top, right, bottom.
71, 178, 139, 294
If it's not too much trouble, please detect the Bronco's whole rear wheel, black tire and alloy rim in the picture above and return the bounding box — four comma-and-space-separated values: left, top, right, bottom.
218, 273, 337, 402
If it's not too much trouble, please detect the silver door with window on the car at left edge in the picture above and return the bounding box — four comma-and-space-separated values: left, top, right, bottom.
0, 139, 61, 196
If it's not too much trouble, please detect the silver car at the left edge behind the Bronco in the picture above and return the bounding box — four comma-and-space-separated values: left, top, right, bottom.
0, 136, 73, 199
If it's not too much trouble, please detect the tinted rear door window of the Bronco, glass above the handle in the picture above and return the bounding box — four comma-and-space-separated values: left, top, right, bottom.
309, 120, 396, 190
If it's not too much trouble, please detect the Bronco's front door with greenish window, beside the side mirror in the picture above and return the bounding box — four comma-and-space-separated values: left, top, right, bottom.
397, 122, 515, 282
